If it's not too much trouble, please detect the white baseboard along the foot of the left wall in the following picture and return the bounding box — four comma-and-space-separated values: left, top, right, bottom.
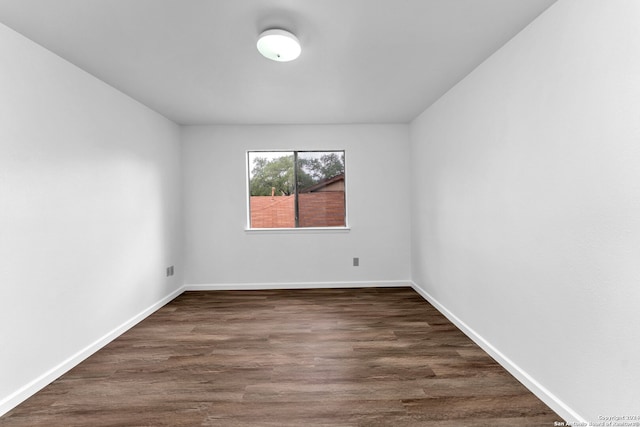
0, 287, 184, 417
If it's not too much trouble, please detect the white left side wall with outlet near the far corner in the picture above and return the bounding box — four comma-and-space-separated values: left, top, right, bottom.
0, 25, 182, 415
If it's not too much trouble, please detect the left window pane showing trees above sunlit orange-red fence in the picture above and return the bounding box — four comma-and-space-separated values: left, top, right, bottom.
249, 151, 296, 228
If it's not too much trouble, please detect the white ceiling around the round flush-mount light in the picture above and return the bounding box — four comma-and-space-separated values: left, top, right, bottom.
0, 0, 555, 124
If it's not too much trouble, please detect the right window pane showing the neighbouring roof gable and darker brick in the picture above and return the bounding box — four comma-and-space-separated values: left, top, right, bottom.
296, 151, 346, 227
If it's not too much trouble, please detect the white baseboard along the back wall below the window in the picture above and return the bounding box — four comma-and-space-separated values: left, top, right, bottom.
184, 280, 412, 291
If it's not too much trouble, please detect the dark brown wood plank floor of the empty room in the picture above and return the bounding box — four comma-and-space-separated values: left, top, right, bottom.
0, 288, 561, 427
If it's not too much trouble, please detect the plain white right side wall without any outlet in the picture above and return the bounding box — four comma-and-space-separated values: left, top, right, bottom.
411, 0, 640, 422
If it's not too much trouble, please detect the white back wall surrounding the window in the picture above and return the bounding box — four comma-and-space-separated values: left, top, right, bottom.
182, 125, 410, 286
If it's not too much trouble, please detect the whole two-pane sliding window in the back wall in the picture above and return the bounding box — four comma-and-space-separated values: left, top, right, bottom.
247, 151, 346, 229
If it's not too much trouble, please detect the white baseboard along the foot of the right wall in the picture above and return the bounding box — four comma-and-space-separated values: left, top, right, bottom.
411, 281, 587, 425
